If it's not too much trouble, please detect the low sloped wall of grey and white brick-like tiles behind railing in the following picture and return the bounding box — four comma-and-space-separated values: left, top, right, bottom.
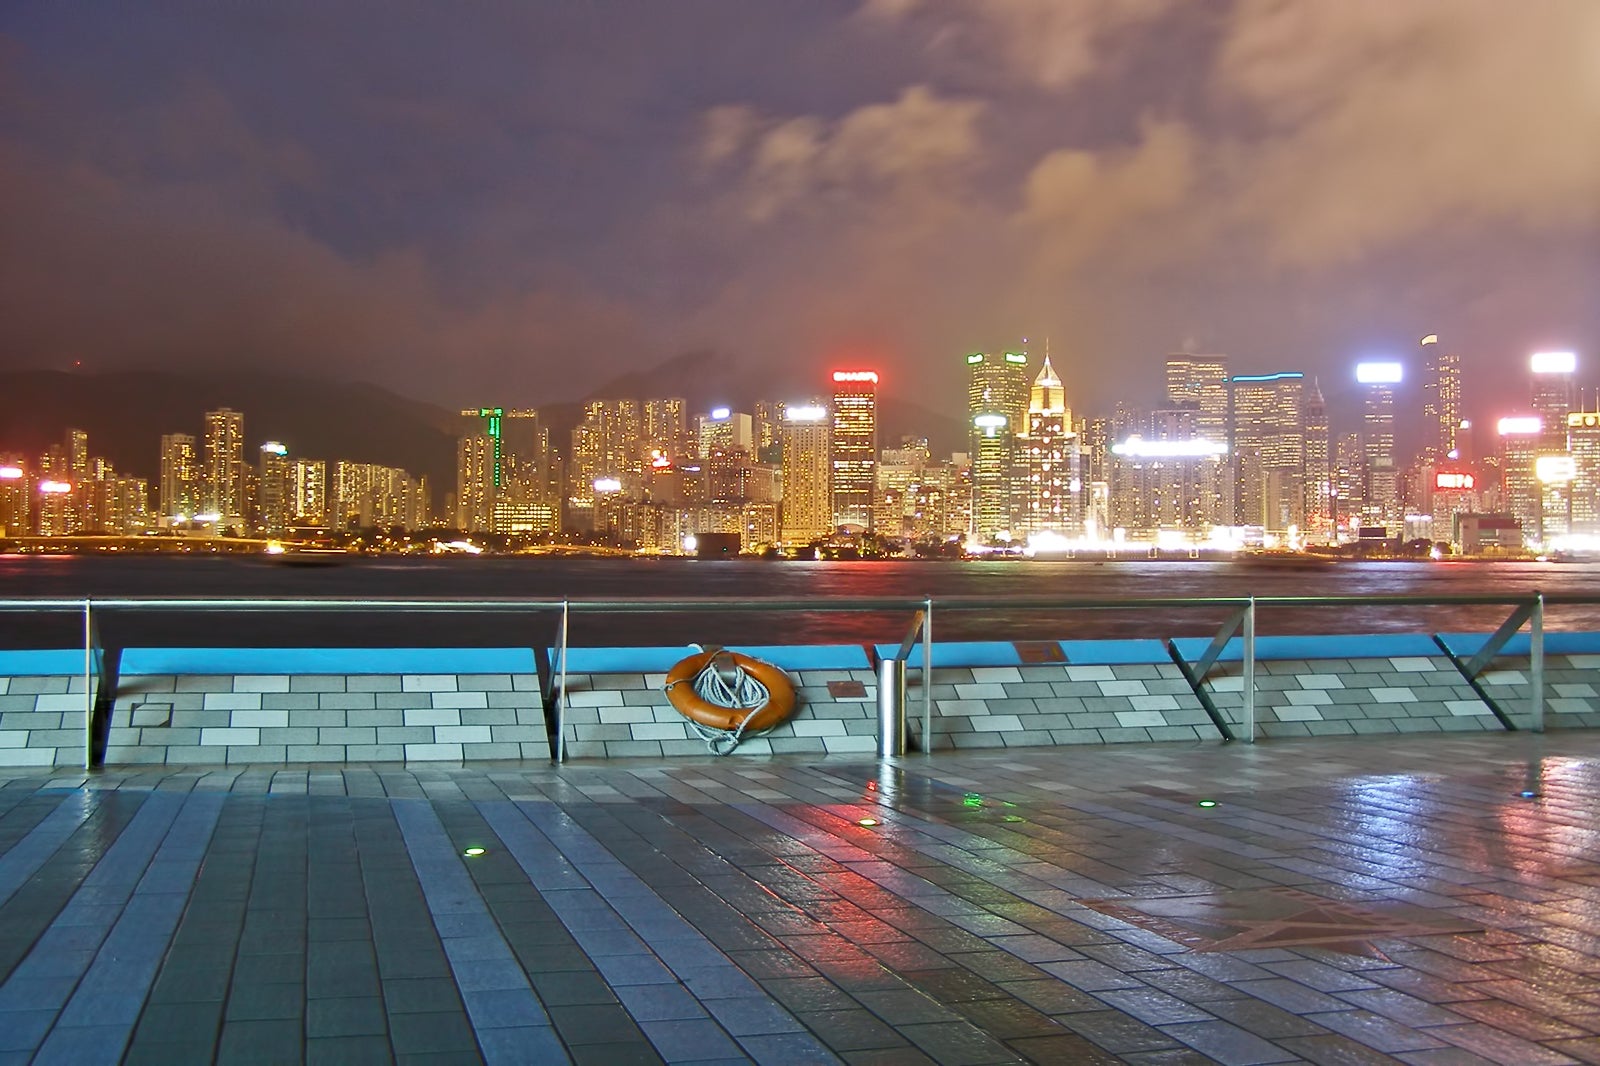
9, 634, 1600, 765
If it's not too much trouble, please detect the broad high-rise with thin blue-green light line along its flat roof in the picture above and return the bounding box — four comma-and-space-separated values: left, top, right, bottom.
1230, 371, 1306, 539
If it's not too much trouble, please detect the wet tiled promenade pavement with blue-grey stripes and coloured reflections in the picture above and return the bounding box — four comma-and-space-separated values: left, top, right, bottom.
0, 731, 1600, 1066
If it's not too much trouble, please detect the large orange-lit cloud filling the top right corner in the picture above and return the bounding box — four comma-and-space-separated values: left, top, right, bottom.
1214, 0, 1600, 266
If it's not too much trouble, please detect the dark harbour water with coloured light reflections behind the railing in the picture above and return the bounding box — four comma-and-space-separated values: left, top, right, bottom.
0, 555, 1600, 647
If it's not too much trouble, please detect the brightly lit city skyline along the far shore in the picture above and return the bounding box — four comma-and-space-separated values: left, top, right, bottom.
0, 335, 1600, 552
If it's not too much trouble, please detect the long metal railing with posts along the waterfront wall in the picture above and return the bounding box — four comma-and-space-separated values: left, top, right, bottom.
0, 592, 1580, 767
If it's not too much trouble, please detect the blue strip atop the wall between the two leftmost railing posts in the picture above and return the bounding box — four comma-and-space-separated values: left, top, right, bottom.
120, 648, 534, 677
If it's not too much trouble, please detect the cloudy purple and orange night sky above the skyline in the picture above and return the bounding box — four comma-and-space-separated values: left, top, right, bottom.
0, 0, 1600, 435
